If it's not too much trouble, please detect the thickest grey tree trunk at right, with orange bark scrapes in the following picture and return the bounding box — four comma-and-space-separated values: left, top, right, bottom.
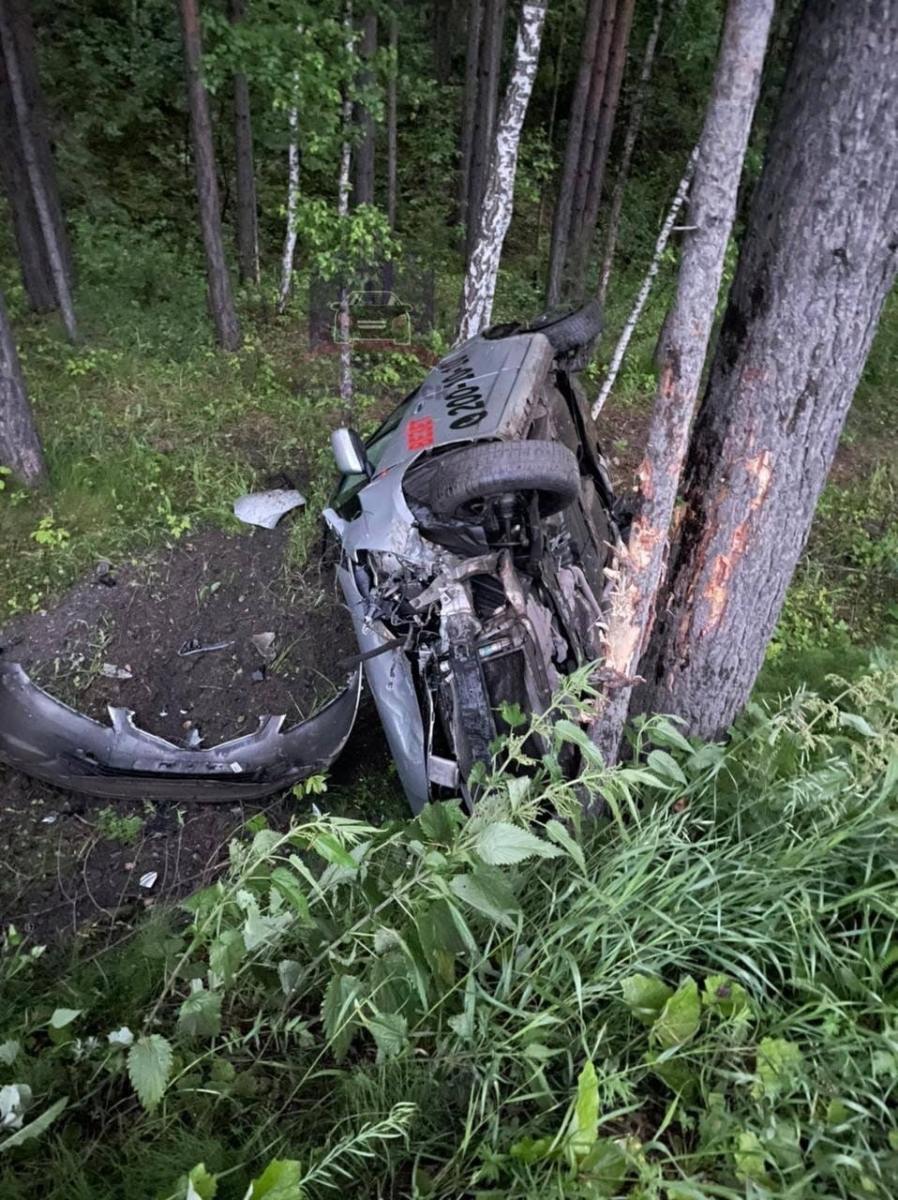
639, 0, 898, 737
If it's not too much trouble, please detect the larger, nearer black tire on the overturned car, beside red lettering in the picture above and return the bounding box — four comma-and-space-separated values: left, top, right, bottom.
429, 440, 580, 518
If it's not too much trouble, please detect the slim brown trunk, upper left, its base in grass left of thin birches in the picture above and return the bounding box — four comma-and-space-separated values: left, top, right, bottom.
179, 0, 241, 350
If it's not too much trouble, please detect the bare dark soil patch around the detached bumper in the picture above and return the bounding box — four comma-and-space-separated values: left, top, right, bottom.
0, 518, 396, 944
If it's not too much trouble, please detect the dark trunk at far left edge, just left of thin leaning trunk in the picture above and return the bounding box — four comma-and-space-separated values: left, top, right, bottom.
0, 62, 59, 312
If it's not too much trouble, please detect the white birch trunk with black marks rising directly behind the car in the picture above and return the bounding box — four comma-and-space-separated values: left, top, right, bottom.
457, 0, 546, 342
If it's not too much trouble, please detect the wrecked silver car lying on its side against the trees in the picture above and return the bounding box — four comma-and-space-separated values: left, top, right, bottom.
324, 305, 618, 811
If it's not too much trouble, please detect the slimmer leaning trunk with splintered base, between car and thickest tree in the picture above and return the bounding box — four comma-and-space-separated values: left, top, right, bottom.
592, 0, 774, 763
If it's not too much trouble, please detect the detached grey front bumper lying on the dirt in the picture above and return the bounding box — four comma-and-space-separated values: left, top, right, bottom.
0, 662, 361, 803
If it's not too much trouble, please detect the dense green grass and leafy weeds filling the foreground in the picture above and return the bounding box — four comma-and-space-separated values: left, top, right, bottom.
0, 652, 898, 1200
